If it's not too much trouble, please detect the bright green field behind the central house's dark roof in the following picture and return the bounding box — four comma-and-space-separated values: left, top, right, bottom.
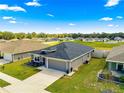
73, 40, 124, 50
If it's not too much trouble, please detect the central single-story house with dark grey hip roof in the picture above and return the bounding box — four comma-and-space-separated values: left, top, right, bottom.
32, 42, 94, 73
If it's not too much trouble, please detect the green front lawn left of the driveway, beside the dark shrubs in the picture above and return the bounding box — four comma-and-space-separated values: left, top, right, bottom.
1, 58, 39, 80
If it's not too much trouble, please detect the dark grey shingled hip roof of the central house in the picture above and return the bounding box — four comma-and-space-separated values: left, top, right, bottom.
35, 42, 94, 60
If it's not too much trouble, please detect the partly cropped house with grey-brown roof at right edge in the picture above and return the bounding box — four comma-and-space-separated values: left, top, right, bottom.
106, 45, 124, 72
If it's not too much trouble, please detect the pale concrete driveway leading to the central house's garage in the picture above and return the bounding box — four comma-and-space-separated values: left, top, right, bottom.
4, 69, 65, 93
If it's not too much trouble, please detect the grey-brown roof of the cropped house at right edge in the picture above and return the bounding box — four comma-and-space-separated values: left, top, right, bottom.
107, 45, 124, 63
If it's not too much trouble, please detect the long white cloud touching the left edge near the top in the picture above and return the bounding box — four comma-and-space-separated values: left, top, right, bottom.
0, 4, 26, 12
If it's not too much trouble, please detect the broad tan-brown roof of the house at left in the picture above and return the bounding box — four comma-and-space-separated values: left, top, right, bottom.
0, 40, 48, 54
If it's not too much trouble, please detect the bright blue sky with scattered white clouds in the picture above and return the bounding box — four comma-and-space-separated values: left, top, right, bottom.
0, 0, 124, 33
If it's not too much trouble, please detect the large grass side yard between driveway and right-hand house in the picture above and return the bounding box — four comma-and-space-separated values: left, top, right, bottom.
46, 58, 124, 93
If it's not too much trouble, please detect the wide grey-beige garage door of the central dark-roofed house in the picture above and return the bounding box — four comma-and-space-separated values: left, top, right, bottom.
48, 59, 67, 72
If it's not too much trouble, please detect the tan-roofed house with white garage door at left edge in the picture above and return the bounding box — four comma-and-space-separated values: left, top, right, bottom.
0, 40, 47, 62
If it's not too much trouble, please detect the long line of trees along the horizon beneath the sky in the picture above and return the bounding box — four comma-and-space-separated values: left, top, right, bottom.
0, 31, 124, 40
